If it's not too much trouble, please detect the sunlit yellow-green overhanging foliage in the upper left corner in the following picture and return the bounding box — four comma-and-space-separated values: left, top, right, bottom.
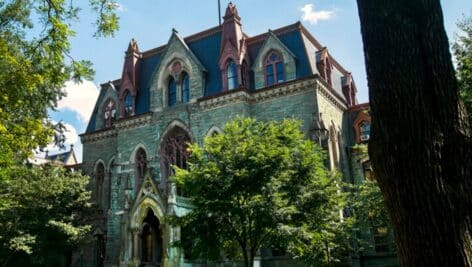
0, 0, 118, 172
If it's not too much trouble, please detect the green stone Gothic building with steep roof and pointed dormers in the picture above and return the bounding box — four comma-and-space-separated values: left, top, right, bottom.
73, 3, 390, 266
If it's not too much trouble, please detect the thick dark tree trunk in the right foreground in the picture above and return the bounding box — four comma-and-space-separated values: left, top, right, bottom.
357, 0, 472, 267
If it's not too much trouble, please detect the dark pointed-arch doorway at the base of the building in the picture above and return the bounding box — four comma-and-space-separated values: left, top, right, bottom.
140, 209, 163, 267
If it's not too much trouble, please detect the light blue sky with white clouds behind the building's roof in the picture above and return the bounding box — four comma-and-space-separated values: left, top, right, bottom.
50, 0, 472, 159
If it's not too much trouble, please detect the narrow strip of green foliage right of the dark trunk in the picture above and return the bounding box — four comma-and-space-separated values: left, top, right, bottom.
452, 17, 472, 127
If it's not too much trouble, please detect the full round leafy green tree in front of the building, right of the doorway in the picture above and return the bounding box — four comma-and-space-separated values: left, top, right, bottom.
174, 118, 345, 265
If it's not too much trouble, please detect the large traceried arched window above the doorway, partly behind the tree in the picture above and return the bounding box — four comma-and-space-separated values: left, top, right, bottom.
161, 127, 190, 193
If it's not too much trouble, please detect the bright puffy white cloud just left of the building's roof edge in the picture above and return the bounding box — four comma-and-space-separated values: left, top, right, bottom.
57, 80, 99, 122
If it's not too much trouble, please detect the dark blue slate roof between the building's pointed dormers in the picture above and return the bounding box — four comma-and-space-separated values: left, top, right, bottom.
86, 22, 346, 133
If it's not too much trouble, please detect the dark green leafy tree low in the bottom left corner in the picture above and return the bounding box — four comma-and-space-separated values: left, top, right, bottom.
0, 165, 90, 266
